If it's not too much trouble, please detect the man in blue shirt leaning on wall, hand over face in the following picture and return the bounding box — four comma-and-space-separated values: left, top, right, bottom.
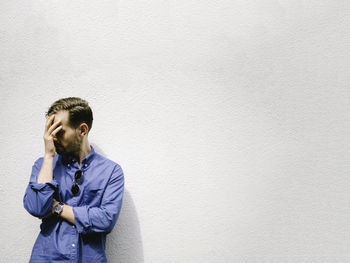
23, 97, 124, 263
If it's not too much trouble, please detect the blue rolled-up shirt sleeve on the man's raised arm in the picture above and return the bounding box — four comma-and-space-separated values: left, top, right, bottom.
23, 157, 58, 218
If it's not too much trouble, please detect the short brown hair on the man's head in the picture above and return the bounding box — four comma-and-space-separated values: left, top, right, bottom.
45, 97, 93, 131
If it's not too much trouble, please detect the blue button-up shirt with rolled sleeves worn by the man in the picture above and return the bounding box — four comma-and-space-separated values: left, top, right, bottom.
23, 145, 124, 263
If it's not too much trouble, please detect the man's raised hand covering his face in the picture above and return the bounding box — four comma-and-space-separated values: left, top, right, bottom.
44, 114, 62, 157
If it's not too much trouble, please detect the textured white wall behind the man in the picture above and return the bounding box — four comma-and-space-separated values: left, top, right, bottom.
0, 0, 350, 263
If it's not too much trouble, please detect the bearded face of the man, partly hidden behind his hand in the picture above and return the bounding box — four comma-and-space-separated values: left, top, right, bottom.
50, 111, 82, 156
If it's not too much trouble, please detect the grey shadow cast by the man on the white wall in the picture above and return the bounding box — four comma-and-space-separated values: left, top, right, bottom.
92, 144, 144, 263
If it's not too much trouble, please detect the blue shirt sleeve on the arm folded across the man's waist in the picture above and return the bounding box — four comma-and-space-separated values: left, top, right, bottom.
73, 166, 124, 234
